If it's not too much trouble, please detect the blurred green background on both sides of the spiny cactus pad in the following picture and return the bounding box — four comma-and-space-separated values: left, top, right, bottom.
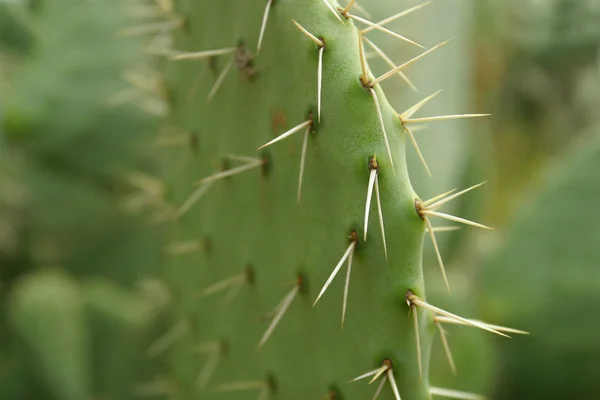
0, 0, 600, 400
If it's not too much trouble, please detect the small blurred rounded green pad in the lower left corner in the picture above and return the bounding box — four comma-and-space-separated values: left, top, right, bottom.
9, 272, 92, 400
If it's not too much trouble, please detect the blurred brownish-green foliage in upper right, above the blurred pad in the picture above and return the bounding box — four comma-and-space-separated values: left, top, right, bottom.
475, 0, 600, 223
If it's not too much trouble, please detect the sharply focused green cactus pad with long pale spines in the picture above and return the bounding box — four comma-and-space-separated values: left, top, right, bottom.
158, 0, 524, 400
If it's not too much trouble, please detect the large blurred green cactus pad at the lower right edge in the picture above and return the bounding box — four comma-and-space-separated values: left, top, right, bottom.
480, 126, 600, 399
